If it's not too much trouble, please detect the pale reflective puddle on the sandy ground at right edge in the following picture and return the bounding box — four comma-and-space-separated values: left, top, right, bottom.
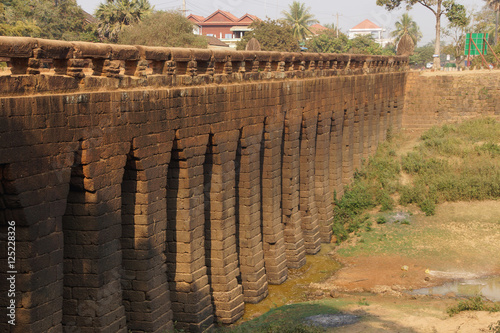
411, 276, 500, 302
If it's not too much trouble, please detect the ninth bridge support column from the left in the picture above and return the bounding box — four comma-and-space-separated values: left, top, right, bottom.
299, 110, 321, 254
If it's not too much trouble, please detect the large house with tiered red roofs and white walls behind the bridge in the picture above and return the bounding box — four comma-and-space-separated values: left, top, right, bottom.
188, 9, 260, 48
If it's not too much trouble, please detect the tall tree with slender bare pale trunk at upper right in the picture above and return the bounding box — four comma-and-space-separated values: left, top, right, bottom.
377, 0, 467, 68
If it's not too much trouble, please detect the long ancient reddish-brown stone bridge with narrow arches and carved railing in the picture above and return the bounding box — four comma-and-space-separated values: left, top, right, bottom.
0, 37, 408, 332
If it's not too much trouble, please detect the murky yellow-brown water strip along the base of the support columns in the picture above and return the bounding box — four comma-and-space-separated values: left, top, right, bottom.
238, 244, 340, 323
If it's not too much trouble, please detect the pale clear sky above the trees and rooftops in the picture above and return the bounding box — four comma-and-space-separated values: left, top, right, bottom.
77, 0, 485, 45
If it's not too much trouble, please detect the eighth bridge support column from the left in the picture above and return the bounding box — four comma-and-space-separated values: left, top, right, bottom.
281, 112, 306, 268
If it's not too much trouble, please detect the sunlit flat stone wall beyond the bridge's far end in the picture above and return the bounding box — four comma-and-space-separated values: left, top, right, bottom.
403, 70, 500, 129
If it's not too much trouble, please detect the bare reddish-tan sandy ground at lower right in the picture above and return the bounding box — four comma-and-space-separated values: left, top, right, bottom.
304, 201, 500, 333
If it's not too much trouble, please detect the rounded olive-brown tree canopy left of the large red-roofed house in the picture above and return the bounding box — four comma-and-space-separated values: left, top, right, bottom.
118, 11, 207, 48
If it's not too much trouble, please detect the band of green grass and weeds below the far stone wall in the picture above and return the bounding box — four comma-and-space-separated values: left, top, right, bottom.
333, 118, 500, 243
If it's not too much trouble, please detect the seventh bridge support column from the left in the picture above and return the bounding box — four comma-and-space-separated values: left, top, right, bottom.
261, 116, 288, 284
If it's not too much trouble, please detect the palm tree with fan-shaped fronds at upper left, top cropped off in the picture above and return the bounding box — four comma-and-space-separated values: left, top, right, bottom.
95, 0, 152, 42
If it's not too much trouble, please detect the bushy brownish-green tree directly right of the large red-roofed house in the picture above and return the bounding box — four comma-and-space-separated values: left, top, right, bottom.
236, 19, 300, 52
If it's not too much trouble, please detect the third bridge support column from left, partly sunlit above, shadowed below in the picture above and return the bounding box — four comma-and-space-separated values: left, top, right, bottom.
121, 131, 174, 333
